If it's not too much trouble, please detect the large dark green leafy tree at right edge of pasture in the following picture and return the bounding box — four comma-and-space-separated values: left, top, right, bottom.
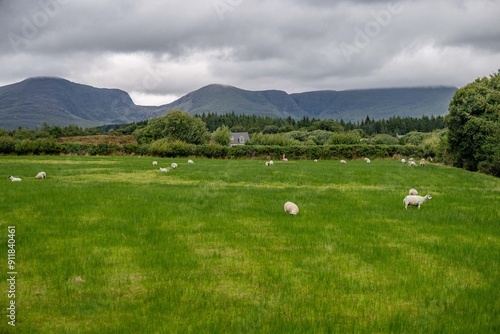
445, 70, 500, 176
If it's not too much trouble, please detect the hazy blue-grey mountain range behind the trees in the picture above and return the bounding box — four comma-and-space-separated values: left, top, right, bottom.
0, 77, 457, 129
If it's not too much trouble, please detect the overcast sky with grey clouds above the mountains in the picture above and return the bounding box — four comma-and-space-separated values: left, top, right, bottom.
0, 0, 500, 105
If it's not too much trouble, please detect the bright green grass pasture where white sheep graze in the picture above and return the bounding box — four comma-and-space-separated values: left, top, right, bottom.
0, 156, 500, 333
